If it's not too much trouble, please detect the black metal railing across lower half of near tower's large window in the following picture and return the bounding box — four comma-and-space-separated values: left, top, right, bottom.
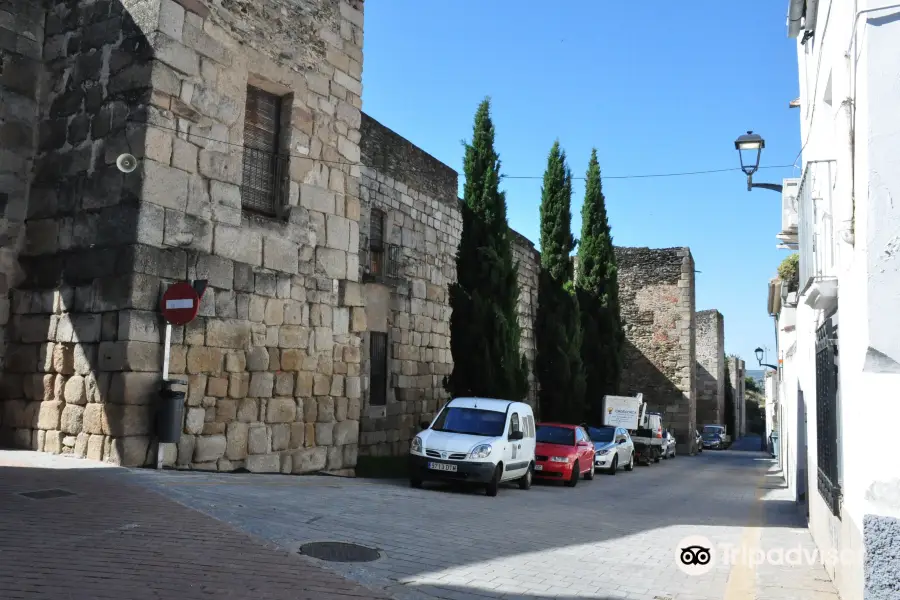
241, 147, 290, 216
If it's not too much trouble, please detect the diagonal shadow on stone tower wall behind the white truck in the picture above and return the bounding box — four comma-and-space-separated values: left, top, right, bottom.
619, 339, 693, 442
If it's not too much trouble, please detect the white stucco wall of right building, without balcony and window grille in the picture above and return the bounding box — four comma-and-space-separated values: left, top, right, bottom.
782, 0, 900, 600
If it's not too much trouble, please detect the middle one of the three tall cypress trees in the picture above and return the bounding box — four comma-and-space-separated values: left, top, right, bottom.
535, 141, 585, 423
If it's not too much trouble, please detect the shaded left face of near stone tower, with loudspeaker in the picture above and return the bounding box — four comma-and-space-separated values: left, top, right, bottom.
0, 0, 156, 465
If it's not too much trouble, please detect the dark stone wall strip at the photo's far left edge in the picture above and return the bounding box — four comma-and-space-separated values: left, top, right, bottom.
0, 0, 46, 398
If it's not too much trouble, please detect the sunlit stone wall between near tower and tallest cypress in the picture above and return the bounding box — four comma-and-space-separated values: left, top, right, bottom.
360, 114, 462, 456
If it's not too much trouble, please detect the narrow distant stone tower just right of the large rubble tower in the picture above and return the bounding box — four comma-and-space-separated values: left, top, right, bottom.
696, 309, 725, 427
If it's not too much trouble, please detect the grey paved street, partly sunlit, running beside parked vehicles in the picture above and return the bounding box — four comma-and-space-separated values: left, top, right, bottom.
132, 441, 837, 600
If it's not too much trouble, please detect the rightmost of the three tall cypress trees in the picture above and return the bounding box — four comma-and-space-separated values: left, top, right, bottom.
575, 148, 625, 425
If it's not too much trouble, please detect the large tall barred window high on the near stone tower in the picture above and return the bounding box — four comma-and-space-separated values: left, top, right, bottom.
241, 86, 287, 215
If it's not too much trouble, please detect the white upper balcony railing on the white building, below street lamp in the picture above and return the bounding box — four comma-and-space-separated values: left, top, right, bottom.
798, 161, 836, 294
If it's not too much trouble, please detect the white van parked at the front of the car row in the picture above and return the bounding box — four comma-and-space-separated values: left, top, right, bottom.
409, 398, 535, 496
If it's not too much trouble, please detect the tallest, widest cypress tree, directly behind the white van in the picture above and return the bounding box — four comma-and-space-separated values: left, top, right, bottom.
444, 99, 528, 400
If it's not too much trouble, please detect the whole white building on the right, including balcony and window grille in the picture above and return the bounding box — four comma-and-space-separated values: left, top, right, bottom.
760, 0, 900, 600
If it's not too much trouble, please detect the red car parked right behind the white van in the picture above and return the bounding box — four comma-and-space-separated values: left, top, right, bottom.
534, 423, 594, 487
